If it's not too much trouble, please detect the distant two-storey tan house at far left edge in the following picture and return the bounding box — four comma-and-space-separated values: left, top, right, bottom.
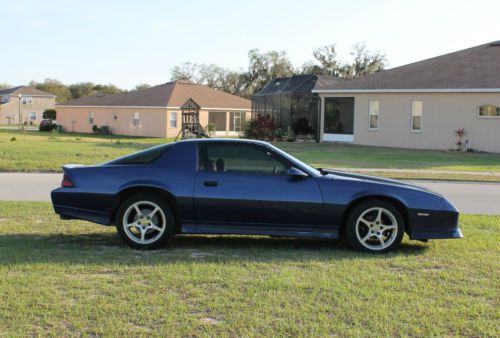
0, 86, 56, 124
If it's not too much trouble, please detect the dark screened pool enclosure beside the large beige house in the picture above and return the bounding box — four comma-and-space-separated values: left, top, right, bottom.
252, 75, 340, 139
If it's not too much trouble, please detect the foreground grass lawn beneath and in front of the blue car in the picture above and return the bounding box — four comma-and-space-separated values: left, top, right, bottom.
0, 202, 500, 337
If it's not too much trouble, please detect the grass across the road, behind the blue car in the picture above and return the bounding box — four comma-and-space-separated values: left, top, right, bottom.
0, 130, 500, 180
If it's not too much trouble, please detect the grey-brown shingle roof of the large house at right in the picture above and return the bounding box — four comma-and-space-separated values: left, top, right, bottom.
313, 41, 500, 93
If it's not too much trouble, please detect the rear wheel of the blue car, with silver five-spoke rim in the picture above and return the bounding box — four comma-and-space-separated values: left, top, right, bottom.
116, 194, 175, 250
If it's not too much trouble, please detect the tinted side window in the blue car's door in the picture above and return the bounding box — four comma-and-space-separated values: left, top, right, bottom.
198, 142, 290, 175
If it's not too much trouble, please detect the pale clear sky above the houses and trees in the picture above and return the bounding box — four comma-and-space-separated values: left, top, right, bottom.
0, 0, 500, 89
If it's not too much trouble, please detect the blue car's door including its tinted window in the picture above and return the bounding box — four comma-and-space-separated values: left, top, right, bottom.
194, 141, 323, 228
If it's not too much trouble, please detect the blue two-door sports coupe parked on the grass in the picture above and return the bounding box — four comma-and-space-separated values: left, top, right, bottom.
52, 139, 462, 253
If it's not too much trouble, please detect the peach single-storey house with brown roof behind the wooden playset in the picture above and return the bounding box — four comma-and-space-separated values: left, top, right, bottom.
57, 80, 251, 137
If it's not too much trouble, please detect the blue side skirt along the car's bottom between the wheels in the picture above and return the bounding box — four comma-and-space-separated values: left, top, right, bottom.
181, 224, 339, 239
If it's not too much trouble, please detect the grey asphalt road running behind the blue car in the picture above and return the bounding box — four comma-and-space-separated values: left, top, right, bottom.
0, 173, 500, 215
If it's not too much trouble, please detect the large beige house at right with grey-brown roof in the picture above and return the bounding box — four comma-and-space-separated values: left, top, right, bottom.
313, 41, 500, 153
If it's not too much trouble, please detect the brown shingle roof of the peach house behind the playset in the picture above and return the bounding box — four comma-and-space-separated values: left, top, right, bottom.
58, 80, 251, 109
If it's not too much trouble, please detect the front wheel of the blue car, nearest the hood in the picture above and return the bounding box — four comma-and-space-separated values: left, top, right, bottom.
345, 199, 405, 253
